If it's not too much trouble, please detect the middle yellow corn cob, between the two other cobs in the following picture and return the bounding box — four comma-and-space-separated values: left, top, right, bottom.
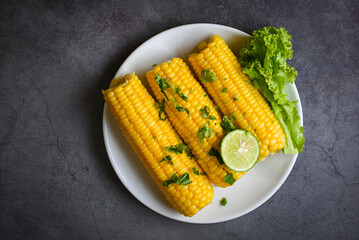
146, 58, 244, 187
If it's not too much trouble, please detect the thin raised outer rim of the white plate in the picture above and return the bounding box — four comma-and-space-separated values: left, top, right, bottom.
102, 23, 303, 224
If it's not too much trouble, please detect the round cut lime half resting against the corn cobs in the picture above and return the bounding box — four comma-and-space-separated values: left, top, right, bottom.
221, 130, 260, 172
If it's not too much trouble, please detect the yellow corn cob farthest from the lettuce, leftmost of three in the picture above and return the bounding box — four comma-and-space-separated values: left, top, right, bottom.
103, 73, 214, 216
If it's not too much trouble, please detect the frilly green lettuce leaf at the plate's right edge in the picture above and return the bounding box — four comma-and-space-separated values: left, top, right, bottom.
239, 27, 304, 154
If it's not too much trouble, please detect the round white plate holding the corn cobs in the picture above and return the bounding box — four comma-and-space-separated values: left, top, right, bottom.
103, 24, 303, 223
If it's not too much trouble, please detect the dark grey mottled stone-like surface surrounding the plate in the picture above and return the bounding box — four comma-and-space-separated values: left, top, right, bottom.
0, 0, 359, 239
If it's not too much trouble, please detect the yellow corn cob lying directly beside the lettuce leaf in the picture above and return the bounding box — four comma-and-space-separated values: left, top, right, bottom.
189, 35, 285, 159
